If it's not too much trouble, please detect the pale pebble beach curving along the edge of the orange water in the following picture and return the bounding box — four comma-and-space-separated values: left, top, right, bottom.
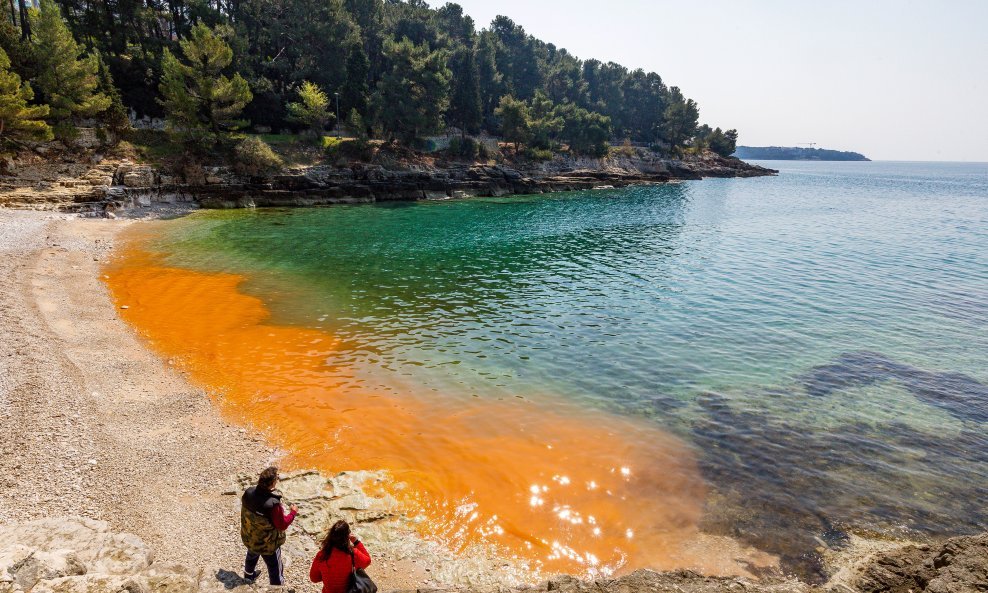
0, 209, 980, 592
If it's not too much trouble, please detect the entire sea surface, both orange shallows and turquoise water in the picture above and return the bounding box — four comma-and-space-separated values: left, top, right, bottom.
107, 161, 988, 580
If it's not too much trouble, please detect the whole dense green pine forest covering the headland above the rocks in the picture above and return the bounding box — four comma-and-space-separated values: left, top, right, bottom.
0, 0, 736, 154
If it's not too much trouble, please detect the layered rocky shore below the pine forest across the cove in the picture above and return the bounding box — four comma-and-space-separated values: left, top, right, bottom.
0, 151, 776, 214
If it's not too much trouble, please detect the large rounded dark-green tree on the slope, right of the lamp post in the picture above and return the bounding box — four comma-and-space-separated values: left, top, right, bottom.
374, 37, 450, 143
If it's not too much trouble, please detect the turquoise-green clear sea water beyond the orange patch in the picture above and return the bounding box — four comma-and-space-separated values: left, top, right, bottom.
152, 162, 988, 576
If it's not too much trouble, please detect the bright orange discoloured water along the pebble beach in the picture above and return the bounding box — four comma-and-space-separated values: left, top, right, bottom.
105, 229, 740, 573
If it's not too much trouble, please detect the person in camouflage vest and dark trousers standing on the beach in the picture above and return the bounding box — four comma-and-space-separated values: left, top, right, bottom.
240, 467, 298, 585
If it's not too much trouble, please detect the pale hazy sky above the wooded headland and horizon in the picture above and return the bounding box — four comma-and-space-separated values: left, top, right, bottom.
452, 0, 988, 162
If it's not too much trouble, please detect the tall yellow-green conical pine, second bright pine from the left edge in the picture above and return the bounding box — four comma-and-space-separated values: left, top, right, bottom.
33, 0, 112, 124
